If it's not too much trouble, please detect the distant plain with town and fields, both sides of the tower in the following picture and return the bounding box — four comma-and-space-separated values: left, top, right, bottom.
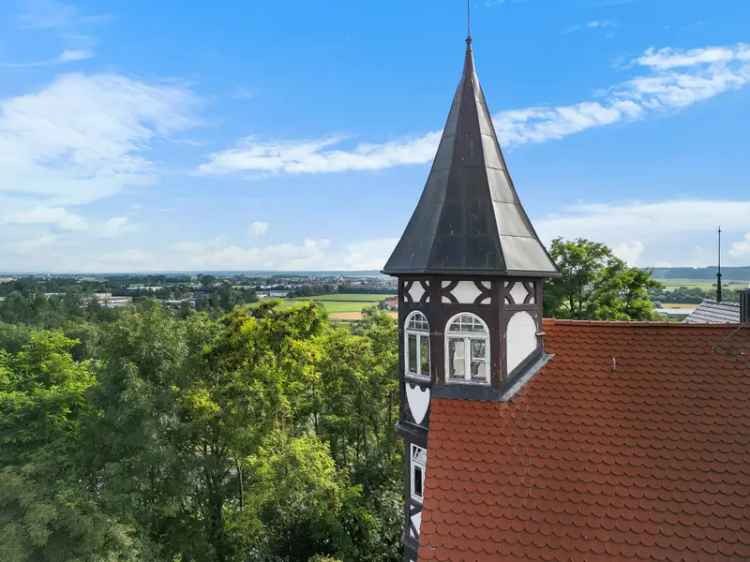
0, 267, 750, 321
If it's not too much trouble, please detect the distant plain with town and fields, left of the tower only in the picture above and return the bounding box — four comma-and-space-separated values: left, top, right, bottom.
0, 271, 398, 321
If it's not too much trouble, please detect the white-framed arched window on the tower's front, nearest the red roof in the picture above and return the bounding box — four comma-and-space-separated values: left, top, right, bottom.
445, 312, 490, 384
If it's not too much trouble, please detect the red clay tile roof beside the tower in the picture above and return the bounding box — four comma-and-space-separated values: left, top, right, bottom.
419, 321, 750, 562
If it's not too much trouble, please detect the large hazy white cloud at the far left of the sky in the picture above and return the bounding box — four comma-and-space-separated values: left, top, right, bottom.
0, 74, 195, 206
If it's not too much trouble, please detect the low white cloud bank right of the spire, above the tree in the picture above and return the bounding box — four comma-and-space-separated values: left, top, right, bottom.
533, 199, 750, 266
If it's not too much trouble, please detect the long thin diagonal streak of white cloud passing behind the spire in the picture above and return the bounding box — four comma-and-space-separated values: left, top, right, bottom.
199, 43, 750, 174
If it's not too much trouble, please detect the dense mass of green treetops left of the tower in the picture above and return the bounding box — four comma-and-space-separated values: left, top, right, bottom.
0, 302, 403, 562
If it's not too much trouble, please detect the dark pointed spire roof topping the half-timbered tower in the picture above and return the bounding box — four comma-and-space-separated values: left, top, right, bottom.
383, 39, 558, 277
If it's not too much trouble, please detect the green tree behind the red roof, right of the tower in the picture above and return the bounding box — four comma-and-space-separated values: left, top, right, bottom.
544, 238, 661, 320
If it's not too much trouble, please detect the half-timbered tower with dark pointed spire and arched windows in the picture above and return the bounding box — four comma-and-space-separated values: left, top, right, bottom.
383, 36, 559, 560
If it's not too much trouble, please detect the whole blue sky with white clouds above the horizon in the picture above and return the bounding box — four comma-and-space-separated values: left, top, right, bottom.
0, 0, 750, 272
